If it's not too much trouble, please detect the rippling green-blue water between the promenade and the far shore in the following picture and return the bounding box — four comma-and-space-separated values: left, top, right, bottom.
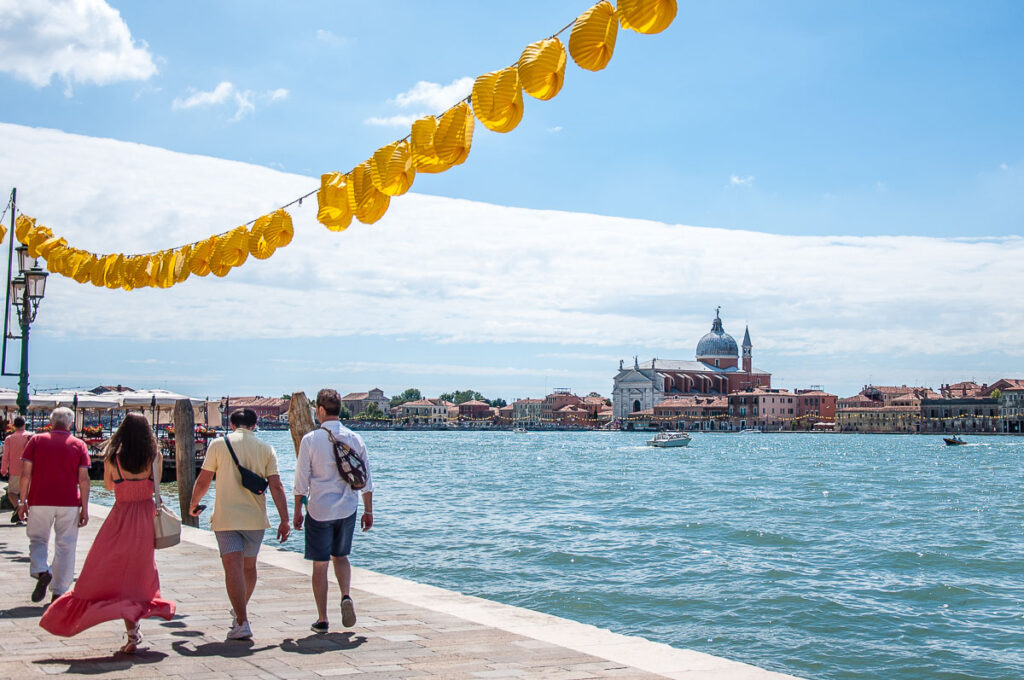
97, 431, 1024, 680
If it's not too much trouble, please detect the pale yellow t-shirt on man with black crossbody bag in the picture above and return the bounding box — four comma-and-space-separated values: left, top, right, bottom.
203, 427, 278, 532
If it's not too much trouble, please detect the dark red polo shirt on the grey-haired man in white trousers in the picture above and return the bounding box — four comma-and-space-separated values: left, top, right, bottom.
22, 430, 90, 508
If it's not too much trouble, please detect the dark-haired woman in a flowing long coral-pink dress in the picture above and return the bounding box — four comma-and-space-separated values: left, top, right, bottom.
39, 414, 174, 653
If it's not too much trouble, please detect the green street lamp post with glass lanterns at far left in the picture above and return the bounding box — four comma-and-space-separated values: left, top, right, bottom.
0, 188, 49, 416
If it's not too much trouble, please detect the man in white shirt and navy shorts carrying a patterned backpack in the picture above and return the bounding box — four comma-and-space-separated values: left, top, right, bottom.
294, 389, 374, 633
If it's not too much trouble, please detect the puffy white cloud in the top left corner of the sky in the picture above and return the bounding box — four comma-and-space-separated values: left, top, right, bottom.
0, 0, 157, 96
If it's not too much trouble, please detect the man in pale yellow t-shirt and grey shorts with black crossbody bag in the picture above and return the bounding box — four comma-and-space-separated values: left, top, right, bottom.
189, 409, 291, 640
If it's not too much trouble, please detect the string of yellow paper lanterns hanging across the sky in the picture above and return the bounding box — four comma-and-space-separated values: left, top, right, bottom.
12, 0, 677, 290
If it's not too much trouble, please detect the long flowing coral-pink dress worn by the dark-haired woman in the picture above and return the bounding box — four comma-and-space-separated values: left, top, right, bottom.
39, 466, 174, 637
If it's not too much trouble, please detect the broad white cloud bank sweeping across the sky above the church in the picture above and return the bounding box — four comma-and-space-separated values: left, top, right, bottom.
0, 124, 1024, 370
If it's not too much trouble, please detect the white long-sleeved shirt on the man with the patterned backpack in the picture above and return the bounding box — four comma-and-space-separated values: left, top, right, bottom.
294, 420, 374, 522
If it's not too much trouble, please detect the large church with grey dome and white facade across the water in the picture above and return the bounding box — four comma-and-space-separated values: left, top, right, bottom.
611, 307, 771, 418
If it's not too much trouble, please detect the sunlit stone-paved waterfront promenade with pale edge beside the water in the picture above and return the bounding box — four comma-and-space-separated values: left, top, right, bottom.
0, 504, 792, 680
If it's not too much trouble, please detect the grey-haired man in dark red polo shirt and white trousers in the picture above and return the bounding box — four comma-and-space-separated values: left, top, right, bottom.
17, 407, 89, 602
